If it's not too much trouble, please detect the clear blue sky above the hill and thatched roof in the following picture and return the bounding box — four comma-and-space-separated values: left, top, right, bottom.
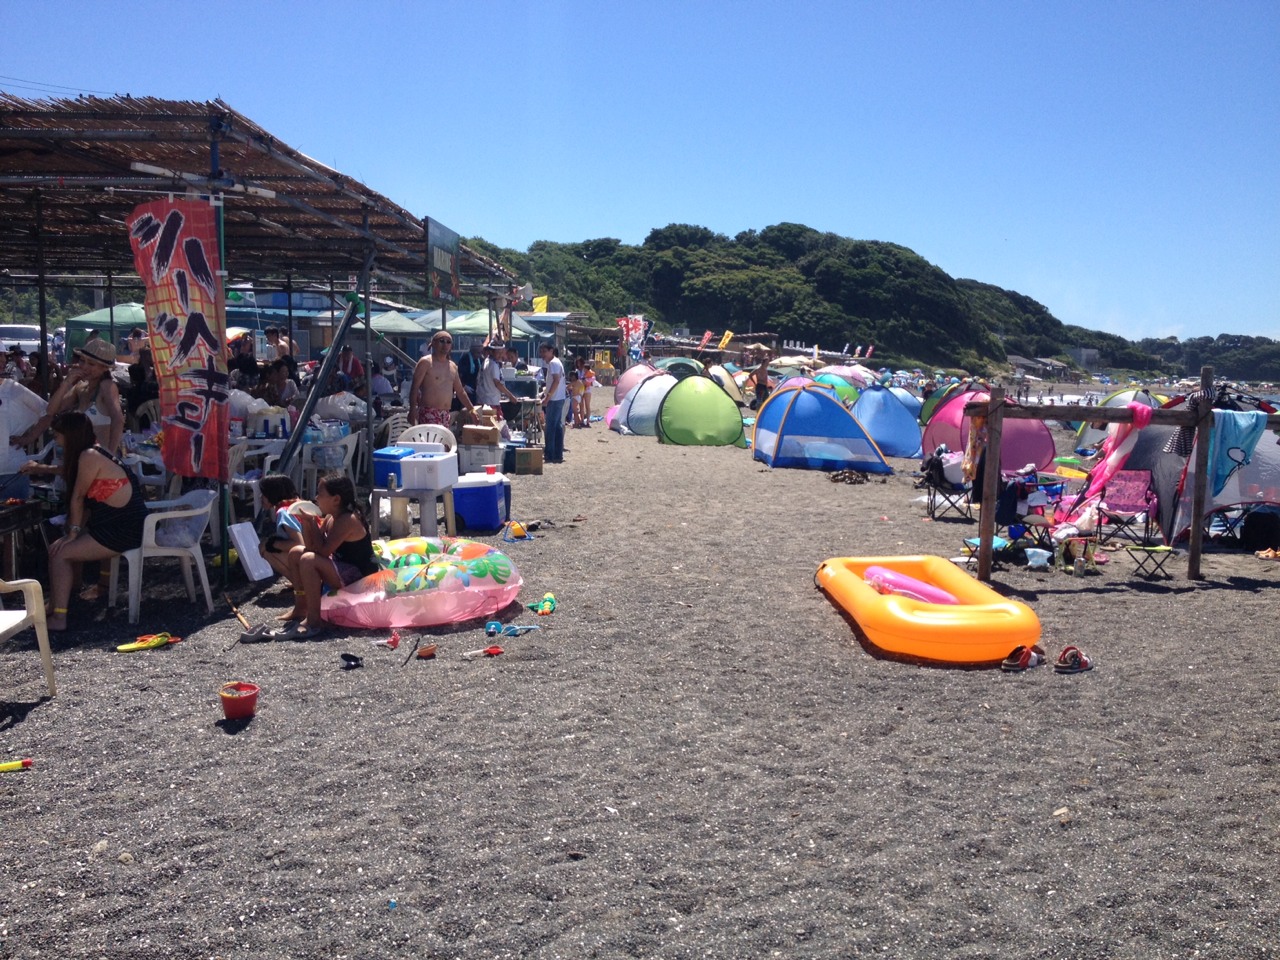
0, 0, 1280, 339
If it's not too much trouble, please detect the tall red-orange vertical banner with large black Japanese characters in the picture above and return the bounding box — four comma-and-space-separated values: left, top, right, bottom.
128, 200, 230, 483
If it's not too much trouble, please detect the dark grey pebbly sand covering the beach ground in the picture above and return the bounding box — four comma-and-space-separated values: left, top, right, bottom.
0, 391, 1280, 960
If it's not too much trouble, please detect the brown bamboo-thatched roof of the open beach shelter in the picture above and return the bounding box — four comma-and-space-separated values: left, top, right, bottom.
0, 92, 515, 292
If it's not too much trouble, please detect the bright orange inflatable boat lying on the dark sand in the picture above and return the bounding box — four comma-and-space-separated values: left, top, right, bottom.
818, 557, 1041, 663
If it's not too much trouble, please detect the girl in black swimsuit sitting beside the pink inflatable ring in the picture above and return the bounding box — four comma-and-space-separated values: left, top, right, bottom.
287, 474, 378, 639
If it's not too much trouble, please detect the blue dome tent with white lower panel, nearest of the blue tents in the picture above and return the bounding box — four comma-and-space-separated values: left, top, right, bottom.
751, 385, 893, 474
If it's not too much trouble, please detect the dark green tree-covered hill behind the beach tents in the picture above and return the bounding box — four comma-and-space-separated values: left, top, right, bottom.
468, 223, 1280, 380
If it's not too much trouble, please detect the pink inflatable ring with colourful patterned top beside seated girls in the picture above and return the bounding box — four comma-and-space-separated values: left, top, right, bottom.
320, 536, 524, 627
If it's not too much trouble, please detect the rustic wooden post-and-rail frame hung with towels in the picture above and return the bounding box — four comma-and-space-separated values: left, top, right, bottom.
964, 366, 1280, 581
